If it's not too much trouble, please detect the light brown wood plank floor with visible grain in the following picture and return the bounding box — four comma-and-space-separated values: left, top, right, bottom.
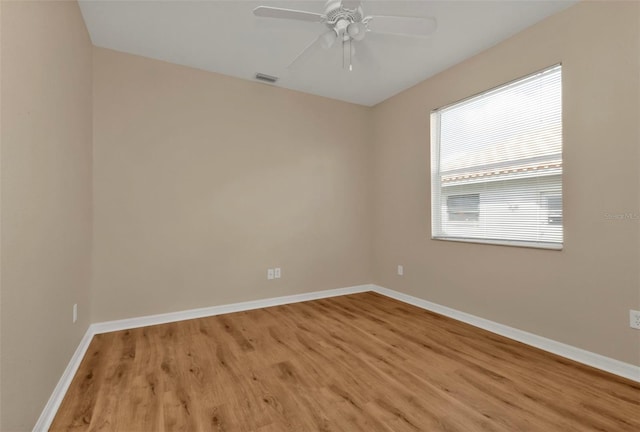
51, 293, 640, 432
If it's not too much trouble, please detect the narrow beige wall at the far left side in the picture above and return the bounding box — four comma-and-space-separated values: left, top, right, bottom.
0, 1, 92, 432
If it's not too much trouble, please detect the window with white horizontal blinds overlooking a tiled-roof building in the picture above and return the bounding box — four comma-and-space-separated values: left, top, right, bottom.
431, 65, 563, 249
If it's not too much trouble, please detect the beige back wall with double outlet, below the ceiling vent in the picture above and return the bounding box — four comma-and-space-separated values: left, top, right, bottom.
92, 48, 371, 321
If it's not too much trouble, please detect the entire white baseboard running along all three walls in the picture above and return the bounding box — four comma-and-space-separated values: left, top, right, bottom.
33, 285, 640, 432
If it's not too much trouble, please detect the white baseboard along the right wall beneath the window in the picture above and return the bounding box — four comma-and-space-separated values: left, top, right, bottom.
371, 285, 640, 382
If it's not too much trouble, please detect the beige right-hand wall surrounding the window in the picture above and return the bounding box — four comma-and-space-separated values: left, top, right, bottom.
373, 2, 640, 365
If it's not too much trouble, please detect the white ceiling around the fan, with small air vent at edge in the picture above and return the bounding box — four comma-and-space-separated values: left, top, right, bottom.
80, 0, 578, 106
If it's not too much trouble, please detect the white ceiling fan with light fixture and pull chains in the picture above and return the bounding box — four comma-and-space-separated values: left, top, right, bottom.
253, 0, 436, 71
